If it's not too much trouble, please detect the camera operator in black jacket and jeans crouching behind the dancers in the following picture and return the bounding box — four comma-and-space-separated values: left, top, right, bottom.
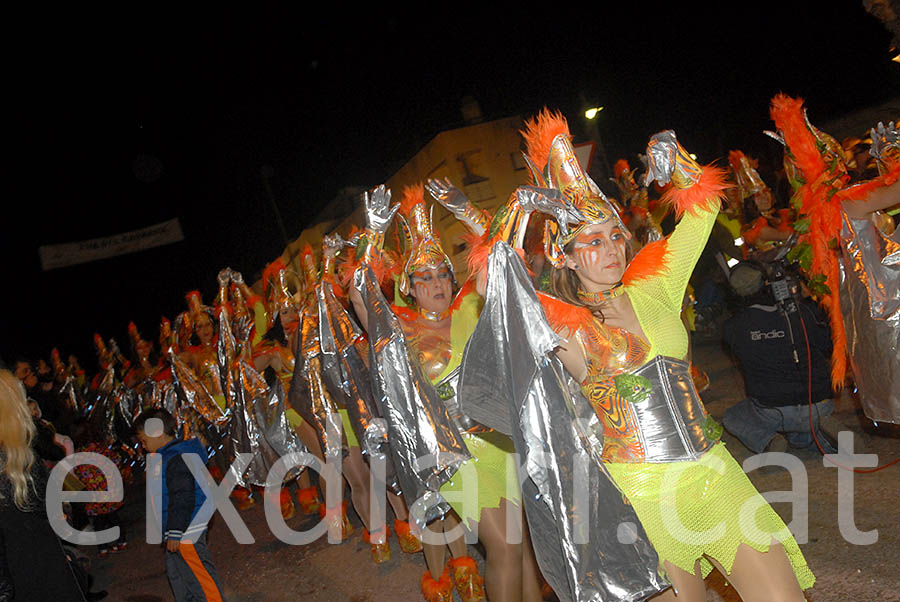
722, 263, 840, 453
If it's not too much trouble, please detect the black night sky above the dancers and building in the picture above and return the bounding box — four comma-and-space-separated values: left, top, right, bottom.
0, 0, 900, 366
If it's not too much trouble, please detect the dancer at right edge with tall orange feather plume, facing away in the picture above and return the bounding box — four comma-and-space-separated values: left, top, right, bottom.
766, 94, 900, 423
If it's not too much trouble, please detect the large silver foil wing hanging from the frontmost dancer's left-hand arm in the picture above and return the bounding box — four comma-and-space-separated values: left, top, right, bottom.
459, 243, 668, 602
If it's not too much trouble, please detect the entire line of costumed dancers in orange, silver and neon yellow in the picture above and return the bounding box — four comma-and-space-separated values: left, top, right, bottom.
22, 96, 900, 602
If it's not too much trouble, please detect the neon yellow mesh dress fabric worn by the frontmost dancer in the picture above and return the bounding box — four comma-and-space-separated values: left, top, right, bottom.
579, 200, 815, 589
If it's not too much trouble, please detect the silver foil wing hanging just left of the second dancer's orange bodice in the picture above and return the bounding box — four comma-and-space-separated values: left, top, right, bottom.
354, 266, 471, 522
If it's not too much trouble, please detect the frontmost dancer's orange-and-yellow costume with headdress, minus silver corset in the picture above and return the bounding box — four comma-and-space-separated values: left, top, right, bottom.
491, 114, 815, 589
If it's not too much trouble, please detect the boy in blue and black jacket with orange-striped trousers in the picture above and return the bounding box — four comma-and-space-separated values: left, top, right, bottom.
134, 408, 225, 602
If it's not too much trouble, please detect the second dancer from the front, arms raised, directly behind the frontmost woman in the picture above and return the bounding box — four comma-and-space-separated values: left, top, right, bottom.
351, 182, 540, 601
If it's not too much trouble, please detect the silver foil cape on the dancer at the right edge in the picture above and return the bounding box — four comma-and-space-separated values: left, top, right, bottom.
840, 214, 900, 423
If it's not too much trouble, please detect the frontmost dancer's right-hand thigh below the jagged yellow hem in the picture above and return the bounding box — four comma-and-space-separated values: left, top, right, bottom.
710, 541, 806, 602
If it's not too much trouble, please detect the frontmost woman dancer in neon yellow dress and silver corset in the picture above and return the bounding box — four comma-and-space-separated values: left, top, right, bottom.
478, 112, 814, 601
